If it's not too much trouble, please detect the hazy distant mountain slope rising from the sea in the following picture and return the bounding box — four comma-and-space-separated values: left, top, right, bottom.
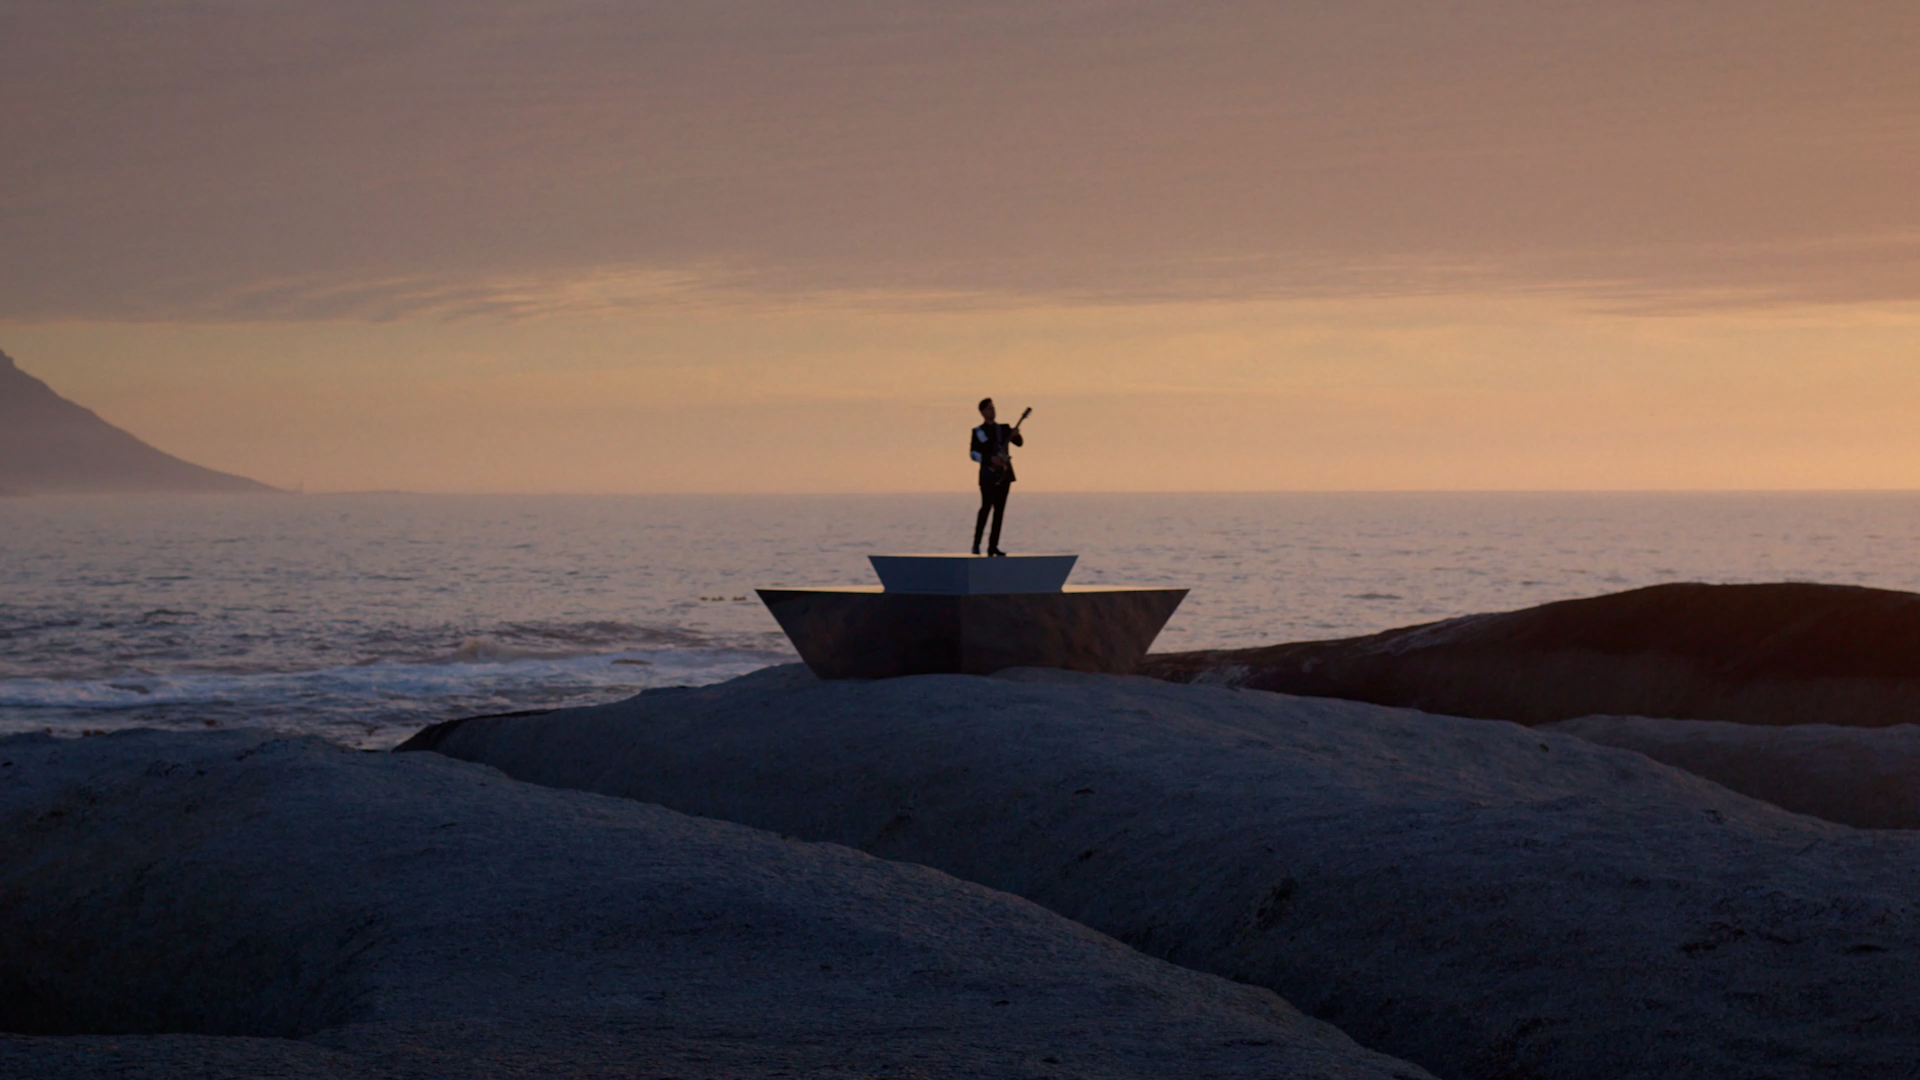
0, 352, 276, 496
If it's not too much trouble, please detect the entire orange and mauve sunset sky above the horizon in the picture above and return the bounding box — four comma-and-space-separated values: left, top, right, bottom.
0, 0, 1920, 492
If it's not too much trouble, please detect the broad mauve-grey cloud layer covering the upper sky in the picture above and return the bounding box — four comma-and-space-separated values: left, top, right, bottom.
0, 0, 1920, 321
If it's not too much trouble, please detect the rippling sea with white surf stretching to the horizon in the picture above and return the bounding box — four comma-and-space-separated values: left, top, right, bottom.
0, 490, 1920, 748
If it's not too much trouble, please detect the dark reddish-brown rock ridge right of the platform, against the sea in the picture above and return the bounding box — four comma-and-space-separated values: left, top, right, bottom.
1139, 584, 1920, 726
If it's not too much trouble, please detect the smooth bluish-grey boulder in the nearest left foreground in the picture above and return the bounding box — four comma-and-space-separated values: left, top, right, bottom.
0, 730, 1427, 1080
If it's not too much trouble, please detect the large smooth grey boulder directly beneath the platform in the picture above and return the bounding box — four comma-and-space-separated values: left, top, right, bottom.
413, 665, 1920, 1080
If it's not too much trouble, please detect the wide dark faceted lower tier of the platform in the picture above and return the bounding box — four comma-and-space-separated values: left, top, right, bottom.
758, 588, 1187, 678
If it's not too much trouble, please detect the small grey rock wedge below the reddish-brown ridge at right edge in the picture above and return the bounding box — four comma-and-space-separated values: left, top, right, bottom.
1542, 717, 1920, 828
